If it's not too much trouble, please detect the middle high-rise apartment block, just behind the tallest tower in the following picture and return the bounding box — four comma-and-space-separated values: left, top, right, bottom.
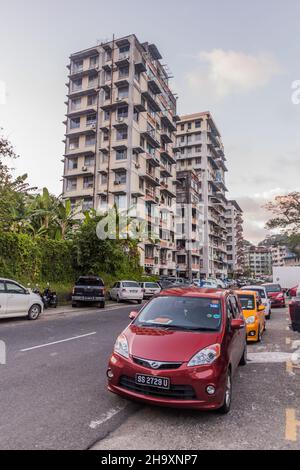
174, 112, 228, 277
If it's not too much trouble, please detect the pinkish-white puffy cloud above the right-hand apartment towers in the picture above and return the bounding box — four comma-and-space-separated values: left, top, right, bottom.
187, 49, 281, 98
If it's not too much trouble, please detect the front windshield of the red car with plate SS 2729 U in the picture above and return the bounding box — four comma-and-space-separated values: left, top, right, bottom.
135, 296, 222, 331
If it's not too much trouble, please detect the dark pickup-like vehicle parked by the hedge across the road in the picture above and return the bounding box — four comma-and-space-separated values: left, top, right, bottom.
72, 276, 105, 308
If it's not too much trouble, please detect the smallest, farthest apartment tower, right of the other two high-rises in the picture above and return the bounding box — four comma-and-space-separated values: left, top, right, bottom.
226, 200, 244, 275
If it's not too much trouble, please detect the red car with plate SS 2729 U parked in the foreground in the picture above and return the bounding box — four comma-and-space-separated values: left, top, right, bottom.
107, 287, 247, 413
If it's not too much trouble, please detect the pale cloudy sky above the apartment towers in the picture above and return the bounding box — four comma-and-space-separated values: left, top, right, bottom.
0, 0, 300, 243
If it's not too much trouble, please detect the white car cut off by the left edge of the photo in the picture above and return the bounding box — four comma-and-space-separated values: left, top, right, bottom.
0, 278, 44, 320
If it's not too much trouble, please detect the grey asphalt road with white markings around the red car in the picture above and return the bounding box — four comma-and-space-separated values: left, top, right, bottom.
0, 304, 300, 450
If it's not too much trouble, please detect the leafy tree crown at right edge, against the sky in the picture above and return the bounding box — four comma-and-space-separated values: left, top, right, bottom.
265, 191, 300, 235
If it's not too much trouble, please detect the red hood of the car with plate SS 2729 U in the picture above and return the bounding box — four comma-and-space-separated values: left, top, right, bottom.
125, 325, 220, 362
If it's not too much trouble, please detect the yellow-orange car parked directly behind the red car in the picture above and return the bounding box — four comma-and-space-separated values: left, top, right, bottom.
237, 290, 266, 342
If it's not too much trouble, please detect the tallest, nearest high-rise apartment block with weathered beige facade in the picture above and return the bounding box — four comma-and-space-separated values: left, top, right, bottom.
63, 35, 176, 275
